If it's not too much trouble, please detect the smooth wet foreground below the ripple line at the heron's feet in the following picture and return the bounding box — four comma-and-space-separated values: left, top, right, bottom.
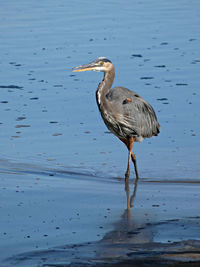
1, 162, 200, 266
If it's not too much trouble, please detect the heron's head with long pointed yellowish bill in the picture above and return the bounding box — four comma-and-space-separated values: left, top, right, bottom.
73, 57, 113, 72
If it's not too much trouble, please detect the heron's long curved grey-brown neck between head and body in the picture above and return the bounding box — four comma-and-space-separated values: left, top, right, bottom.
96, 67, 115, 109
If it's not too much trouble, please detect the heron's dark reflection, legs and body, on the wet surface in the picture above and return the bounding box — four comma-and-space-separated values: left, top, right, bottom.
96, 179, 152, 259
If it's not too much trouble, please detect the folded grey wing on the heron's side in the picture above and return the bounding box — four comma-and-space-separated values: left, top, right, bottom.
107, 87, 160, 141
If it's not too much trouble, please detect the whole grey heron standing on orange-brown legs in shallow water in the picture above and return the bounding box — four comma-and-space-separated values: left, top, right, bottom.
72, 57, 160, 180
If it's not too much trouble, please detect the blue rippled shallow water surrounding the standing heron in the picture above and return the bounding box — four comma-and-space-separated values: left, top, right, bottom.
0, 0, 200, 266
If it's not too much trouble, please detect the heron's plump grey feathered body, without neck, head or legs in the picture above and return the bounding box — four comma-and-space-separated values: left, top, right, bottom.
97, 87, 159, 142
